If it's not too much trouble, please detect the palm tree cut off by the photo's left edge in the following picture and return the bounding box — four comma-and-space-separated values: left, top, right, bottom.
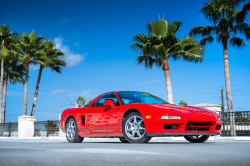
0, 25, 18, 123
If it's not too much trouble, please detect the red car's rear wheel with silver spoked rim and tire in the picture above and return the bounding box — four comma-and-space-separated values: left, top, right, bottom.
66, 118, 84, 143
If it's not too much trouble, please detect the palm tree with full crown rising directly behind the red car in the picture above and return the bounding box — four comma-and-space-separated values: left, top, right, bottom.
131, 19, 204, 103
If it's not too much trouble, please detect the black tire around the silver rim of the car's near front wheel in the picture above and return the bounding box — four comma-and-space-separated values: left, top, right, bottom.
122, 112, 151, 143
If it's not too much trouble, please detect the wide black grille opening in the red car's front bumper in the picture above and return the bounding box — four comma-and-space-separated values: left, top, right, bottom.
185, 121, 210, 131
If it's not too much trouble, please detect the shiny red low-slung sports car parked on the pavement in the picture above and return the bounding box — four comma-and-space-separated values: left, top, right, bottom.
60, 91, 222, 143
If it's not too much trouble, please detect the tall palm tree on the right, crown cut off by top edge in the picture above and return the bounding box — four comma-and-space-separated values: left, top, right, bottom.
190, 0, 250, 127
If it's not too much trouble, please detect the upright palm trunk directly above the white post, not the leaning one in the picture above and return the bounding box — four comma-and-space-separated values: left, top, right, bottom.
23, 58, 29, 115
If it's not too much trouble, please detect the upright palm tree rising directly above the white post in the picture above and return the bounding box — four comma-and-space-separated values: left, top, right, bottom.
17, 30, 44, 116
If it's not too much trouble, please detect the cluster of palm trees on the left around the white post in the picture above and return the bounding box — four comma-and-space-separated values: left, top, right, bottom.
0, 25, 66, 123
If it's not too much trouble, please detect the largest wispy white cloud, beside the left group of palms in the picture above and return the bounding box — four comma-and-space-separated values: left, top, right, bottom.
54, 37, 88, 67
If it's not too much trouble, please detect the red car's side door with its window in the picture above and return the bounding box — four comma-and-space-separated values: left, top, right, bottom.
86, 93, 121, 134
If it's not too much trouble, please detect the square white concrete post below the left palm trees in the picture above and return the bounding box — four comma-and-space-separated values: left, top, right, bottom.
18, 115, 36, 138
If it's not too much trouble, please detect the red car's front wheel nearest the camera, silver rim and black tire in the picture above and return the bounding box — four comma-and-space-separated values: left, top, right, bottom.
122, 112, 151, 143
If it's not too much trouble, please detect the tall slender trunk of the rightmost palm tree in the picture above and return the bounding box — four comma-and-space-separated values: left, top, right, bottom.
222, 36, 236, 136
